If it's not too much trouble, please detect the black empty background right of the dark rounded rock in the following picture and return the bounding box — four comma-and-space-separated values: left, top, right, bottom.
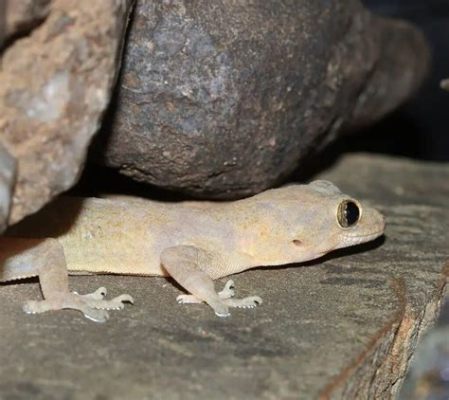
356, 0, 449, 161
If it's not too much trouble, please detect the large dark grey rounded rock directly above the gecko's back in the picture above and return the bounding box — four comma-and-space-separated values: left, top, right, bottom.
97, 0, 428, 198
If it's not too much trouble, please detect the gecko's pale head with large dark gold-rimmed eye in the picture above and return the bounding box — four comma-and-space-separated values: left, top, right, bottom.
250, 180, 385, 265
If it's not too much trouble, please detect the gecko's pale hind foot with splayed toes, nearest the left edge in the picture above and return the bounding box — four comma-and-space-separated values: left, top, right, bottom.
23, 288, 134, 322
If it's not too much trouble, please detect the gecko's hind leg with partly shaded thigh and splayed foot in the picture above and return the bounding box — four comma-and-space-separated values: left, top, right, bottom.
0, 237, 133, 322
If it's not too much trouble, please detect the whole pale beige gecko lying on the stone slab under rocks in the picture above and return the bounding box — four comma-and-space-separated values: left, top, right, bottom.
0, 181, 385, 321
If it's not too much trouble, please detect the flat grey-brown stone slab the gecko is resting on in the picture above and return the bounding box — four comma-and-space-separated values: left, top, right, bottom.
0, 152, 449, 400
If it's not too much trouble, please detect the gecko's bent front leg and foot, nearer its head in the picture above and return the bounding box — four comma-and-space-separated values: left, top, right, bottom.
161, 246, 262, 317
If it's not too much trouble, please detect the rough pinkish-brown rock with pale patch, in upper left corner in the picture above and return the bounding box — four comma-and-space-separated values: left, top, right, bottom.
0, 0, 132, 223
